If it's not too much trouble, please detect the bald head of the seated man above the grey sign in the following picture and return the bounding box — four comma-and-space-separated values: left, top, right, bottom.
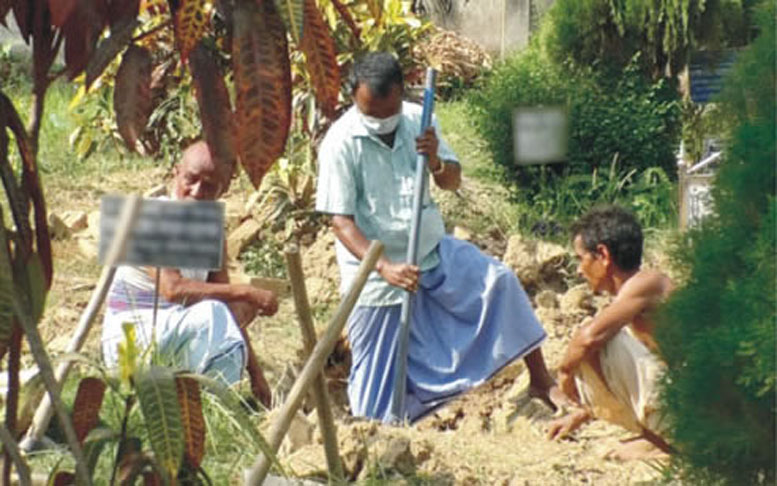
173, 141, 224, 200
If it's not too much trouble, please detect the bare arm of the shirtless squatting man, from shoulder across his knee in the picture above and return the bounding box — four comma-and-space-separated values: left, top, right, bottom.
559, 273, 666, 374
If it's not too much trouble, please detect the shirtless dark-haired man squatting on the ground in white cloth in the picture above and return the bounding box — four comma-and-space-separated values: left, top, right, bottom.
549, 206, 673, 459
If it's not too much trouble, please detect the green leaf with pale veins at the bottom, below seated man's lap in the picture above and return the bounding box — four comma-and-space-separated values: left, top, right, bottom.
135, 366, 184, 478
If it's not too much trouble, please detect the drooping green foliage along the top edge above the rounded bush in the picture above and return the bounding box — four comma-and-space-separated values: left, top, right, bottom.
540, 0, 761, 78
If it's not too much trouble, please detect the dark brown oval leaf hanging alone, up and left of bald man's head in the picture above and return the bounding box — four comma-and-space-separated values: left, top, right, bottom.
113, 45, 152, 151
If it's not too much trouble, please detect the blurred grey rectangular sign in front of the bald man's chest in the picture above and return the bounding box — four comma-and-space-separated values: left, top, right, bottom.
99, 196, 224, 270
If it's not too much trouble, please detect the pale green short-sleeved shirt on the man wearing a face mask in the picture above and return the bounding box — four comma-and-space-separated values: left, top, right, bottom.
316, 102, 458, 306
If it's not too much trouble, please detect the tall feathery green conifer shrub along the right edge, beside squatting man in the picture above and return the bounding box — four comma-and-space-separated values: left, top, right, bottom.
657, 5, 777, 484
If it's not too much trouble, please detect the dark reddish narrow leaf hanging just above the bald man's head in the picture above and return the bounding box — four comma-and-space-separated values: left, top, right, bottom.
189, 43, 237, 189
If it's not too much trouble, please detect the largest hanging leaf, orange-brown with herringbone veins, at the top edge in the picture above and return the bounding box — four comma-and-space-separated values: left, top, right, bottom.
232, 0, 291, 188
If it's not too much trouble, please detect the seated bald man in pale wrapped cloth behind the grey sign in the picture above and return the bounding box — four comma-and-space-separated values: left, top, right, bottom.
102, 142, 278, 407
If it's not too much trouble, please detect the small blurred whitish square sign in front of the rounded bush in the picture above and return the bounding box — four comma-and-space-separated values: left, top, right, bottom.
513, 106, 569, 165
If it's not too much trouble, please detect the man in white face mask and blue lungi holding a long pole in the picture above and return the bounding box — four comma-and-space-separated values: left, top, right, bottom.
316, 53, 556, 421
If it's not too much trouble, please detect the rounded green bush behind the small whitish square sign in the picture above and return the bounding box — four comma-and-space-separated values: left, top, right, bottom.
469, 46, 680, 231
